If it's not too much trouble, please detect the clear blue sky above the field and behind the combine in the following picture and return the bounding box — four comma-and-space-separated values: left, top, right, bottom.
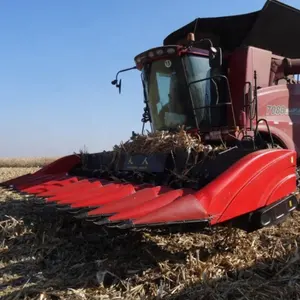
0, 0, 300, 157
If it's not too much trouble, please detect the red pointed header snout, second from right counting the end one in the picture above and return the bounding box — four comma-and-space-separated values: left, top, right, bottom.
108, 190, 183, 221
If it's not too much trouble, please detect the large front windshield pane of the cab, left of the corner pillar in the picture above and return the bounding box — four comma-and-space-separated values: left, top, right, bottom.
143, 57, 196, 130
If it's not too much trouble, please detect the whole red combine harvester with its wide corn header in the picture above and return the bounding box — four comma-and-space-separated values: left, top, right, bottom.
1, 0, 300, 230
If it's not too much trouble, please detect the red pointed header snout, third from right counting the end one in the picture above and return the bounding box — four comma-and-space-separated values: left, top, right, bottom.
88, 186, 161, 216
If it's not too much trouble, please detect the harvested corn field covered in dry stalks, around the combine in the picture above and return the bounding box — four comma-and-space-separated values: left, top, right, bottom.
0, 168, 300, 300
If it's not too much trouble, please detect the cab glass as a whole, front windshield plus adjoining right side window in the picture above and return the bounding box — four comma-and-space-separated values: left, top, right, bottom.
143, 55, 226, 130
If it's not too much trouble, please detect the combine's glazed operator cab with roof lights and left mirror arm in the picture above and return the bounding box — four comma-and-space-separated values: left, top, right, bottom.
112, 33, 230, 132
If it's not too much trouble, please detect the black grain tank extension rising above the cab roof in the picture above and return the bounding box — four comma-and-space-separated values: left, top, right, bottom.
164, 0, 300, 58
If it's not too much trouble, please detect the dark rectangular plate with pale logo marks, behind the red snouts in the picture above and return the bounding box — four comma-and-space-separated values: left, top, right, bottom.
123, 154, 166, 172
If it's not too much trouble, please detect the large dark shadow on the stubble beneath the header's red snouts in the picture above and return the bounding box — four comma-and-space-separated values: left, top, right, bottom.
0, 191, 220, 299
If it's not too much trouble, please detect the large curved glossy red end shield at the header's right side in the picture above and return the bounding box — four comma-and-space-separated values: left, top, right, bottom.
188, 149, 296, 224
